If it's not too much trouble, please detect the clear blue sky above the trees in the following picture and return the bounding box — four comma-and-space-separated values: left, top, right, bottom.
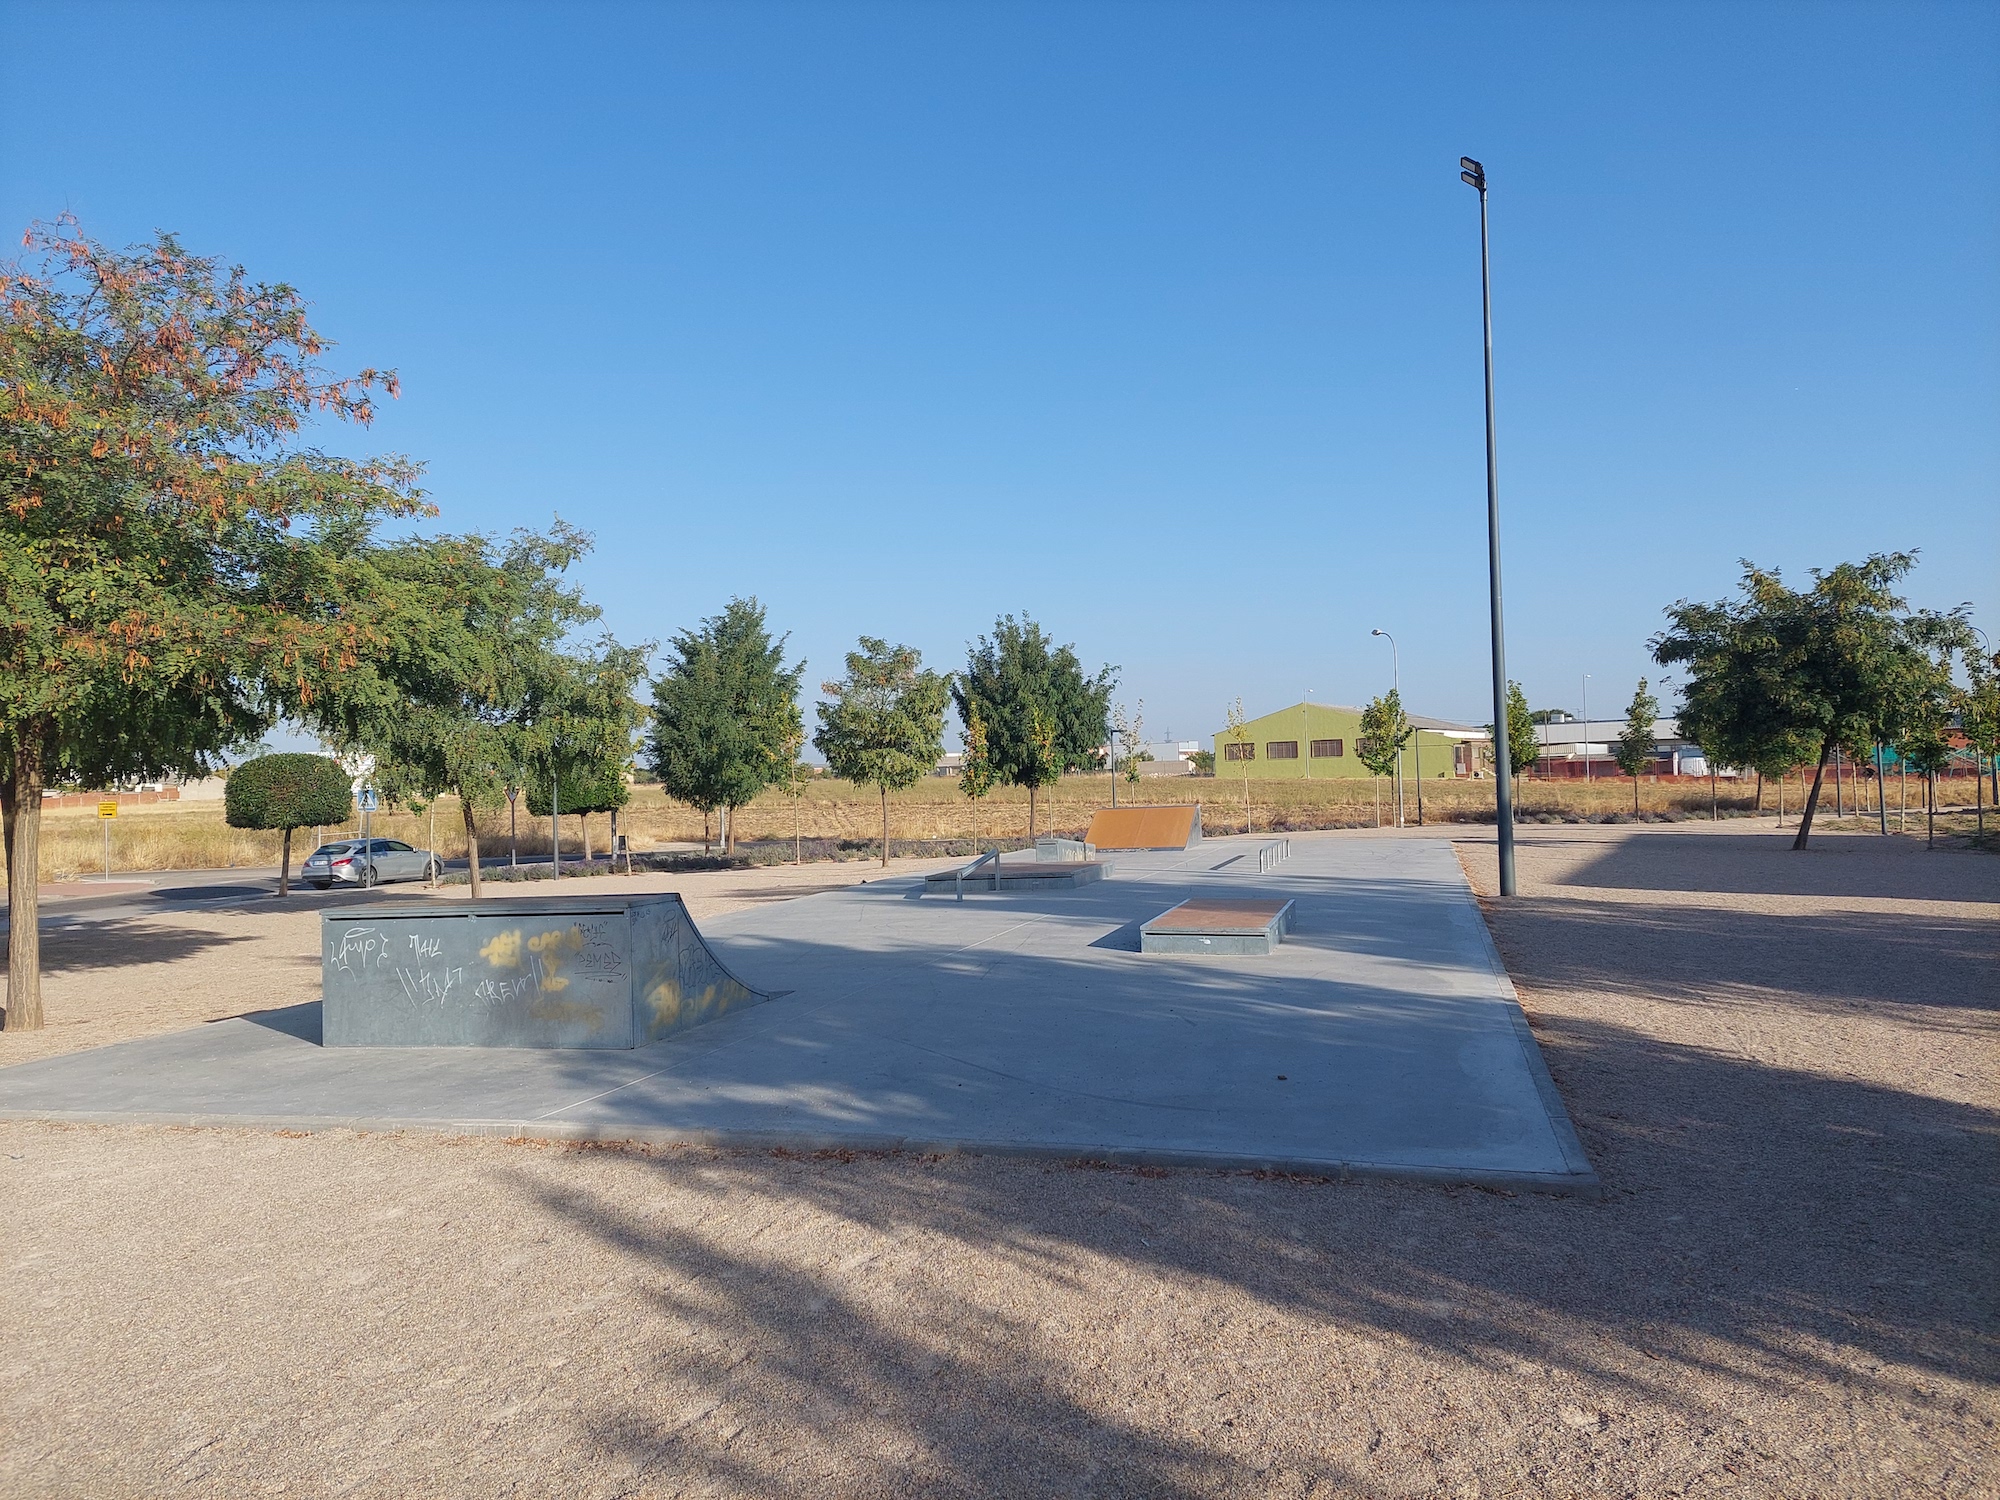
0, 0, 2000, 752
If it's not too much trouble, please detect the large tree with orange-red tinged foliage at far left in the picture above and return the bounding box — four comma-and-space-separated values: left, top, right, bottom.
0, 220, 424, 1030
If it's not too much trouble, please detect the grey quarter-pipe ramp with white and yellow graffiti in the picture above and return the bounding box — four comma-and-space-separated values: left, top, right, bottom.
320, 894, 770, 1048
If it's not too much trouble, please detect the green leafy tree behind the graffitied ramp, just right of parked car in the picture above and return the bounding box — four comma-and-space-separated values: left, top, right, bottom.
350, 518, 600, 900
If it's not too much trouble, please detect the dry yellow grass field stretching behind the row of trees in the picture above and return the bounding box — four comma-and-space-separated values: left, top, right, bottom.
11, 774, 2000, 882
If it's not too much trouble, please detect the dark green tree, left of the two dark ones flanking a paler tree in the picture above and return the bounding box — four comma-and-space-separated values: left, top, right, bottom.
646, 598, 806, 852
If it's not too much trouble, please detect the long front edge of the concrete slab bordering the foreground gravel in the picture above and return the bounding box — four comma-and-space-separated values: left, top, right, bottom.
0, 1108, 1602, 1198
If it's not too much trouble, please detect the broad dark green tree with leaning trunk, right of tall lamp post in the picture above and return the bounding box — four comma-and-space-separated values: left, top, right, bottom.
1650, 552, 1970, 850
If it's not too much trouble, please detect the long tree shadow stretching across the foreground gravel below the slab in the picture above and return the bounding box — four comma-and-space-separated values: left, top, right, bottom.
496, 1004, 2000, 1496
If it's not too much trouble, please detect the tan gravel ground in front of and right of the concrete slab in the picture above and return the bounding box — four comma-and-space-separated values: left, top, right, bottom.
0, 824, 2000, 1500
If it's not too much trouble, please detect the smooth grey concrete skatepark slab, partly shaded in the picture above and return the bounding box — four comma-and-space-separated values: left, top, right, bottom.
0, 834, 1596, 1190
